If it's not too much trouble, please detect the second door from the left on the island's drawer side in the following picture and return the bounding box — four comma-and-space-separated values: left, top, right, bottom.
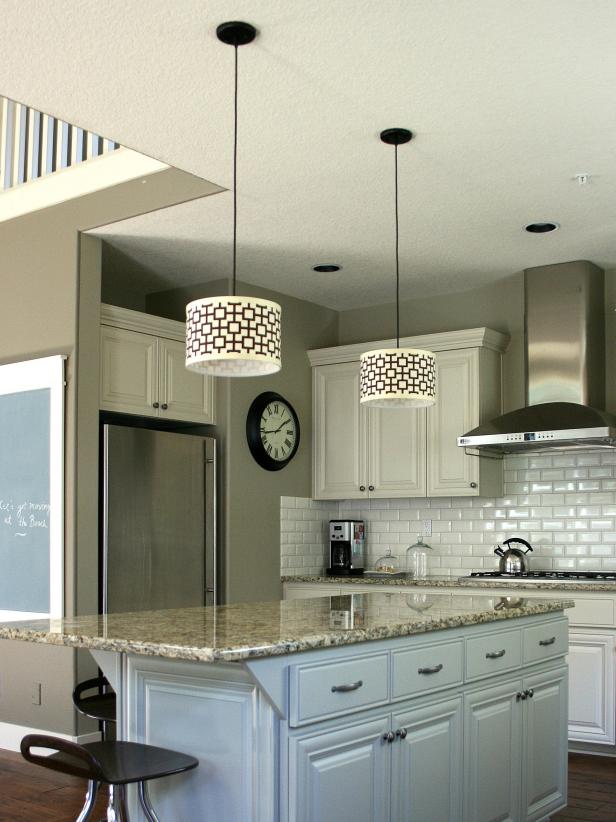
392, 697, 462, 822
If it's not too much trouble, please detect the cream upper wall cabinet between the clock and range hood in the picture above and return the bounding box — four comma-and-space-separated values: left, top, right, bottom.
309, 328, 508, 499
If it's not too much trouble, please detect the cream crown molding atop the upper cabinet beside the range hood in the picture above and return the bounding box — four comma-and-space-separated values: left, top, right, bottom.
308, 328, 509, 366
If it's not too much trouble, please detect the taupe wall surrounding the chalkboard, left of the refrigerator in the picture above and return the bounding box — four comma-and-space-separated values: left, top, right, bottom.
0, 169, 218, 734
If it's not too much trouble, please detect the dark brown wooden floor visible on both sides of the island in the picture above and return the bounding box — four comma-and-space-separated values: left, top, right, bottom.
0, 751, 616, 822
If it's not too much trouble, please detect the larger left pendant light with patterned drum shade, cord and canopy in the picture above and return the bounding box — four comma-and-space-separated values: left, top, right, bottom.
186, 22, 281, 377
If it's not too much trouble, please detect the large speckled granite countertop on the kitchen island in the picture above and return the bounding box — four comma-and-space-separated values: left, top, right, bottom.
0, 592, 573, 662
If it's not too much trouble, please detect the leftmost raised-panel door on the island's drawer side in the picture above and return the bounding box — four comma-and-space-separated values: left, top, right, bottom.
288, 714, 393, 822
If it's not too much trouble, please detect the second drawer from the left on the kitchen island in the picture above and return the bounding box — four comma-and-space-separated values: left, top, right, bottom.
392, 639, 464, 699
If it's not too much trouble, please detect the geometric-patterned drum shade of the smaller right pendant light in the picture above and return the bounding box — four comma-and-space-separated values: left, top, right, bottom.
359, 348, 436, 408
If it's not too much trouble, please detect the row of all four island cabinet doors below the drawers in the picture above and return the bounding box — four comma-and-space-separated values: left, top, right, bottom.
288, 667, 567, 822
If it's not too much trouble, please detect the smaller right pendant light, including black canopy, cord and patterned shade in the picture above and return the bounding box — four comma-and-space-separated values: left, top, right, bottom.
359, 128, 436, 408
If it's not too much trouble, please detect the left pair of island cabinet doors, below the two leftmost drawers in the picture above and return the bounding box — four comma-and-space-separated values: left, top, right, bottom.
289, 697, 462, 822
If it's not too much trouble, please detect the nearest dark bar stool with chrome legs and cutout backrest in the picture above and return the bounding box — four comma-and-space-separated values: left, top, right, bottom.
21, 734, 199, 822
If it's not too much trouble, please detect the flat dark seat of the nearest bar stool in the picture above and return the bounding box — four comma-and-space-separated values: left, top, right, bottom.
47, 742, 199, 785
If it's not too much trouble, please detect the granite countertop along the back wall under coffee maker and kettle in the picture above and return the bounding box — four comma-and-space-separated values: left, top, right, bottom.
281, 574, 616, 594
